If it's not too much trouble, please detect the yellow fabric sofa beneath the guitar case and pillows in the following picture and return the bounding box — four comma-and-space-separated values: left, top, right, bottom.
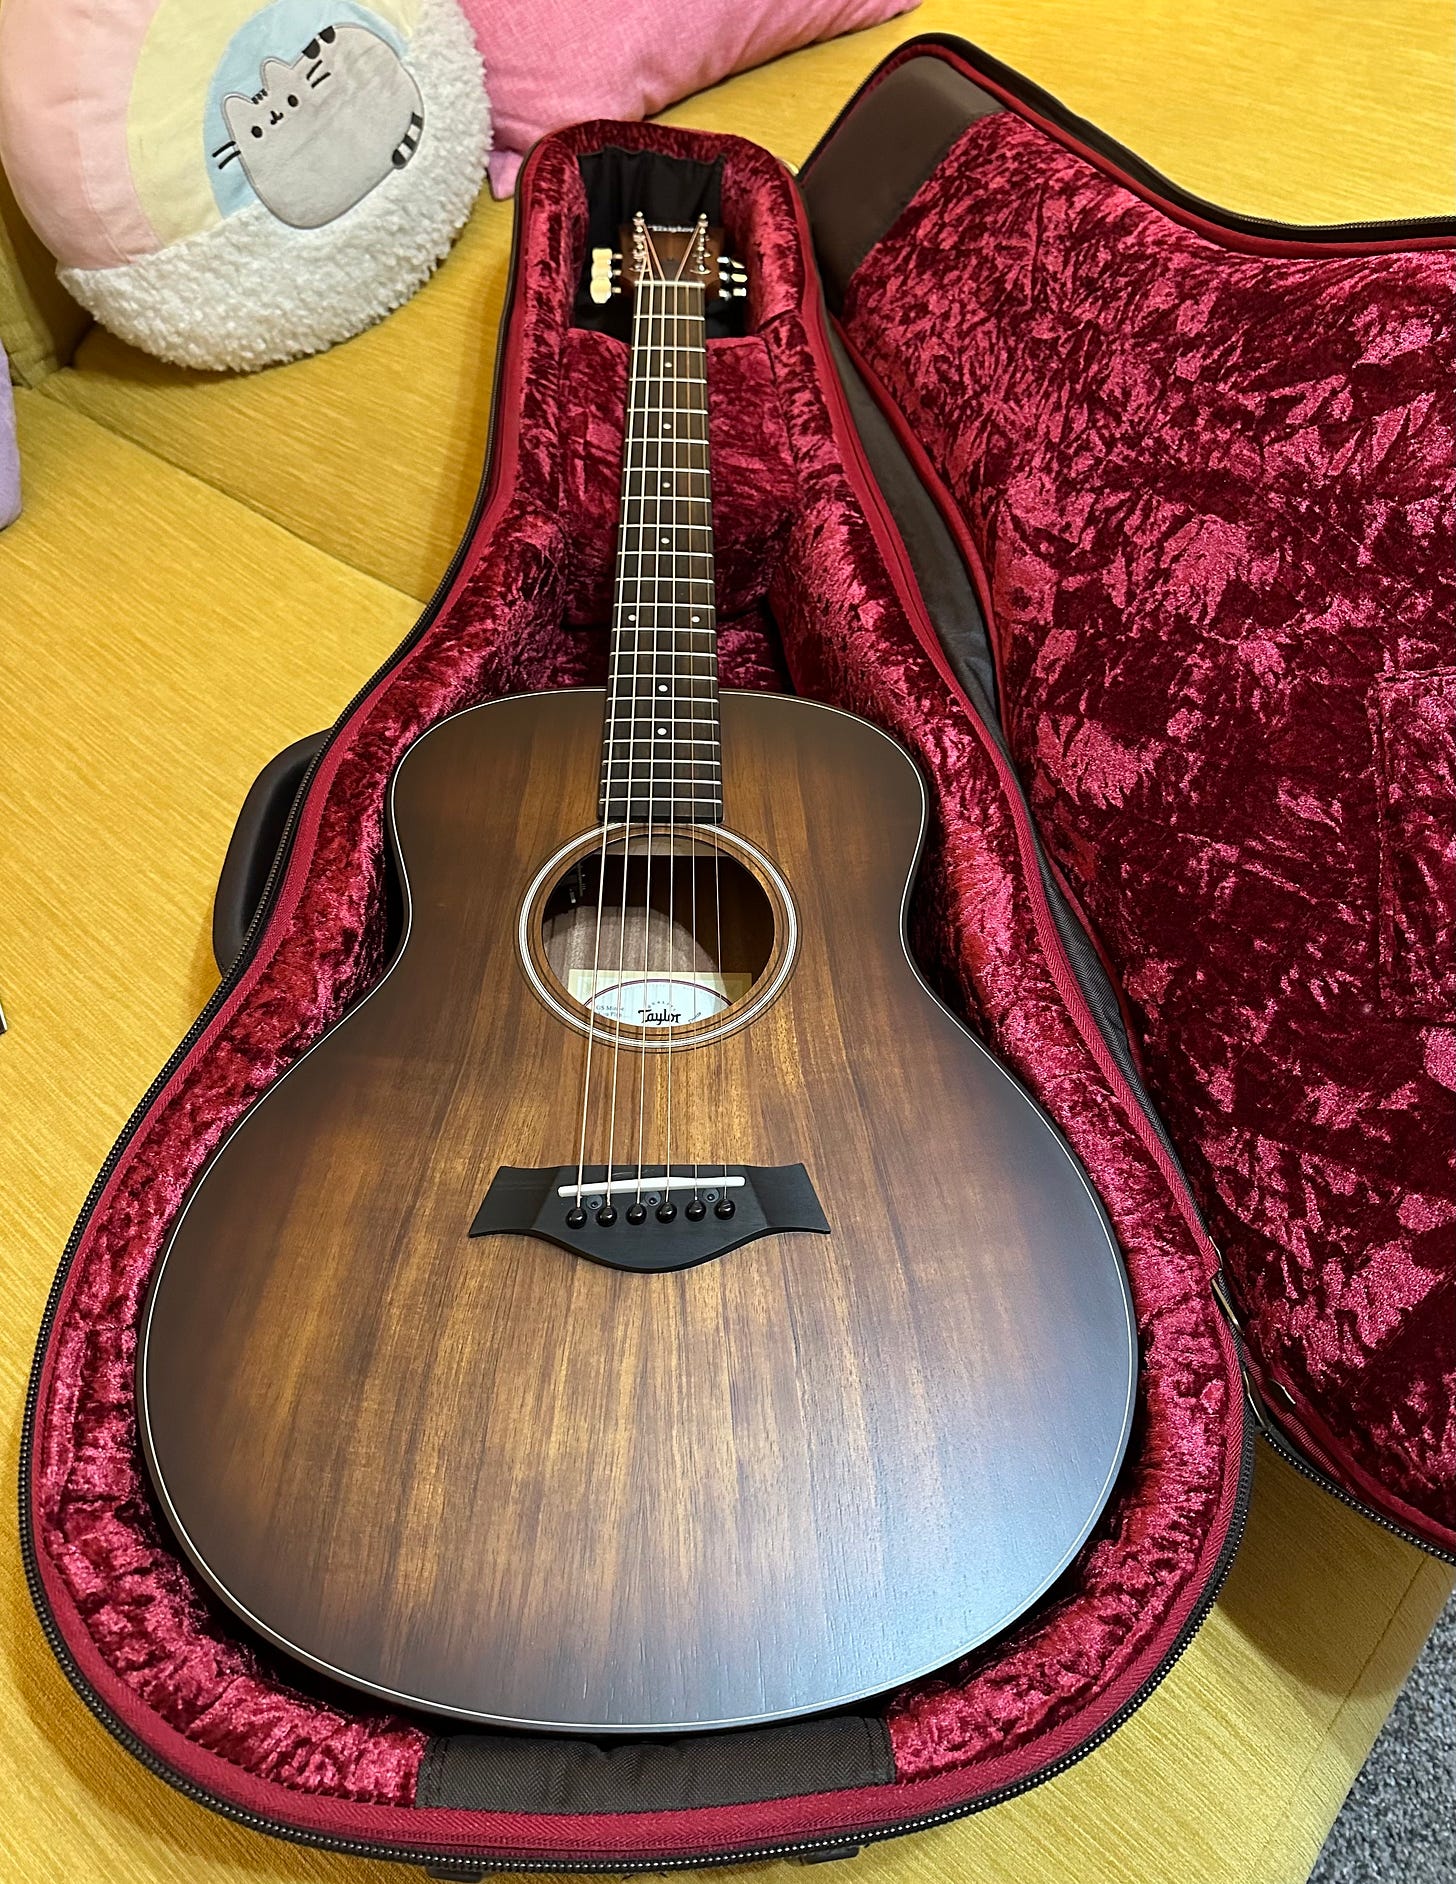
0, 0, 1456, 1884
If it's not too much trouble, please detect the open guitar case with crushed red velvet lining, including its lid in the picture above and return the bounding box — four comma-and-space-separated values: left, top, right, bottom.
21, 40, 1456, 1878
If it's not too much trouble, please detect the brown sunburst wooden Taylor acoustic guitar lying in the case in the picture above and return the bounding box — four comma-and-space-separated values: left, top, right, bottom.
138, 217, 1136, 1735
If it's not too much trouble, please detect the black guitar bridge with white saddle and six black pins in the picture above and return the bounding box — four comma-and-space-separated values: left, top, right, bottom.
469, 1164, 829, 1272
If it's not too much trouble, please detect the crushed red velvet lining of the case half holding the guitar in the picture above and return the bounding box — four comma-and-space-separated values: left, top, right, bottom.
30, 106, 1265, 1858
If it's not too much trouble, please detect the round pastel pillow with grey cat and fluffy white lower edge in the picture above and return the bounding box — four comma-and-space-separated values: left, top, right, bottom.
0, 0, 490, 367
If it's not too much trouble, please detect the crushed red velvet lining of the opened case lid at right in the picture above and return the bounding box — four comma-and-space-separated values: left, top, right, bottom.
844, 111, 1456, 1549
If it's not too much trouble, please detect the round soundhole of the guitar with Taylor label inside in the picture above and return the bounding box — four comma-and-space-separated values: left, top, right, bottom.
522, 827, 793, 1046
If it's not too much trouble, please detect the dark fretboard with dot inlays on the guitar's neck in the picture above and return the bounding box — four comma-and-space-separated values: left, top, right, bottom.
601, 281, 723, 823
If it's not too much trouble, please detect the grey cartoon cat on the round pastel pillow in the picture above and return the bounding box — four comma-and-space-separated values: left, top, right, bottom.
213, 26, 424, 230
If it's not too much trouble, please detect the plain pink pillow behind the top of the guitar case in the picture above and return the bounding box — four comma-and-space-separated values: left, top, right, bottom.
463, 0, 917, 196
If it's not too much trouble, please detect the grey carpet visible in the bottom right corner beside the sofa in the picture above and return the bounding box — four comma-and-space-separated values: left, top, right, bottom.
1309, 1598, 1456, 1884
